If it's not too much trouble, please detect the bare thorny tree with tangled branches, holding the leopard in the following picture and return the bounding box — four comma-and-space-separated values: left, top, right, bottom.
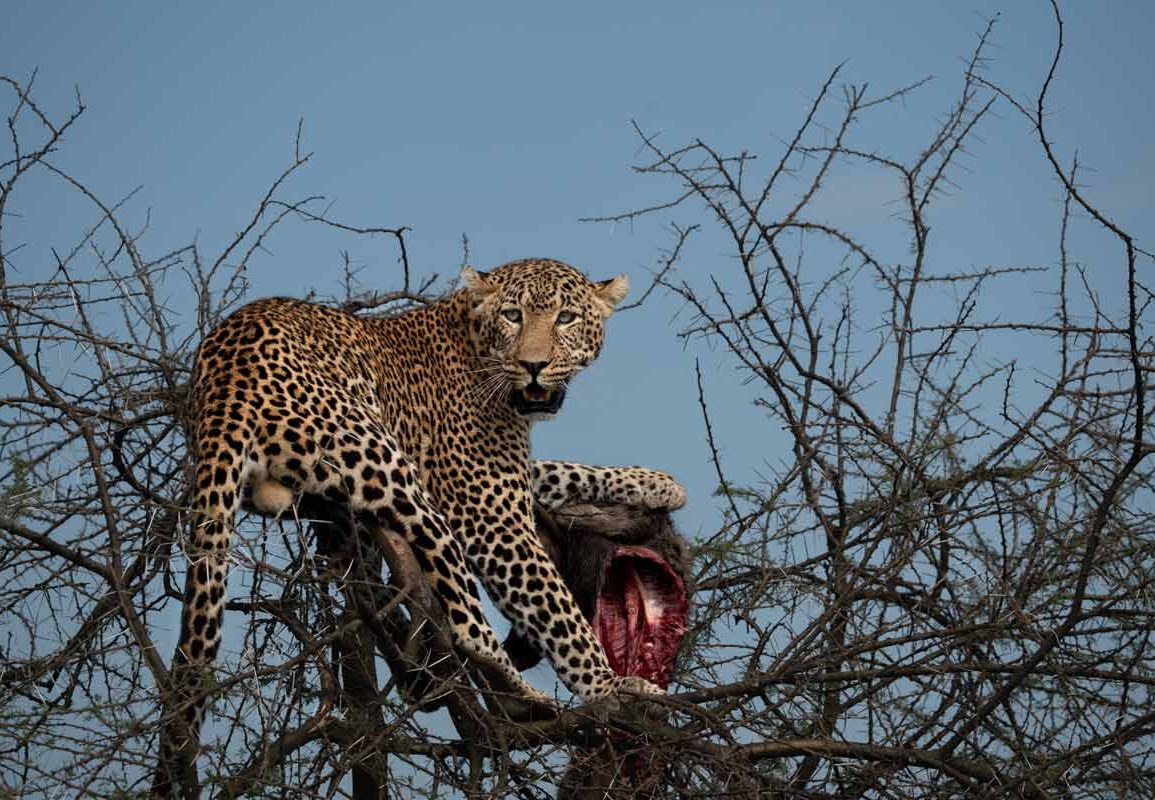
0, 7, 1155, 798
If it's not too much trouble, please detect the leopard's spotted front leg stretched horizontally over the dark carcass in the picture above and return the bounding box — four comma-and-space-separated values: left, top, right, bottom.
530, 461, 686, 511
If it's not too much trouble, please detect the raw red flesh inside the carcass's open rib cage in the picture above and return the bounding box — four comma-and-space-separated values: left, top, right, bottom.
594, 546, 690, 689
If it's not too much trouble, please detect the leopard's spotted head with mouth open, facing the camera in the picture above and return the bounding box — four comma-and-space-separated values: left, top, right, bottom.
461, 259, 629, 419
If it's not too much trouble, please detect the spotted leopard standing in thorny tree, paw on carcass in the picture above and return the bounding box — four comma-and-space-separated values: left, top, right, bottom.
161, 259, 686, 784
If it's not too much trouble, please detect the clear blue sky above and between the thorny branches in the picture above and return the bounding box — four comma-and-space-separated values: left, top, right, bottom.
0, 0, 1155, 542
